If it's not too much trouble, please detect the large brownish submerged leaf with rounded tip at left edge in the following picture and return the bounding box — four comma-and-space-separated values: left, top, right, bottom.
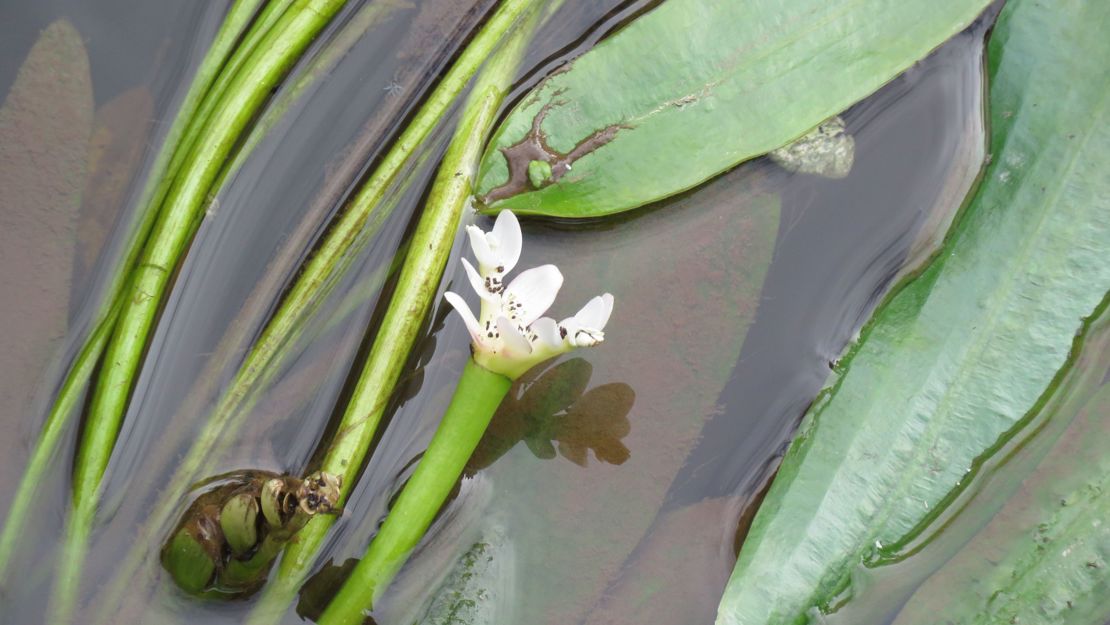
0, 20, 93, 497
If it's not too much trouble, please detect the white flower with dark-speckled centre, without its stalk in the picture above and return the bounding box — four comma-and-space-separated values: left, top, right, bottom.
446, 211, 613, 380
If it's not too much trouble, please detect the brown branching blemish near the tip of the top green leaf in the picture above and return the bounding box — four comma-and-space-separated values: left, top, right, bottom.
478, 103, 630, 204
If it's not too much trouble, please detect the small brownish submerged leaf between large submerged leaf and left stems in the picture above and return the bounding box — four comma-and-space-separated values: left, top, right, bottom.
73, 87, 154, 284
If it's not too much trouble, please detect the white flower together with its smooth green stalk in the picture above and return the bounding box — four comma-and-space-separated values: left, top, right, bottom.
320, 211, 613, 625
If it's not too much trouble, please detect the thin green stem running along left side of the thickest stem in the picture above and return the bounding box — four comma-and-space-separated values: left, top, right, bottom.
0, 0, 262, 585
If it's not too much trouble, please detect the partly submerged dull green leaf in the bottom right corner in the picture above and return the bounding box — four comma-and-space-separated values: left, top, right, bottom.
896, 314, 1110, 625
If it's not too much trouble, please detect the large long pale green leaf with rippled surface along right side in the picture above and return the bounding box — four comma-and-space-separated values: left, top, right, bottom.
718, 0, 1110, 625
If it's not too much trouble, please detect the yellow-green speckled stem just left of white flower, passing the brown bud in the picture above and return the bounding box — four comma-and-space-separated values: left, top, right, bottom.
249, 0, 542, 623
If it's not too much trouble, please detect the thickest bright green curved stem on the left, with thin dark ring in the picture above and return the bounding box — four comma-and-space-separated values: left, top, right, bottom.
53, 0, 344, 623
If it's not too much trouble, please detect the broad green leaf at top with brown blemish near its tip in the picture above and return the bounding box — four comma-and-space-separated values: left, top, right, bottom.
478, 0, 988, 218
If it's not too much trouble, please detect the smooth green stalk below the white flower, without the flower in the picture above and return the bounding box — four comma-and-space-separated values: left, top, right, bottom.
320, 360, 513, 625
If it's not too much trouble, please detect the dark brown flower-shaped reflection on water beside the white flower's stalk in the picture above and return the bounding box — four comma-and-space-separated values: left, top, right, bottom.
467, 357, 636, 474
